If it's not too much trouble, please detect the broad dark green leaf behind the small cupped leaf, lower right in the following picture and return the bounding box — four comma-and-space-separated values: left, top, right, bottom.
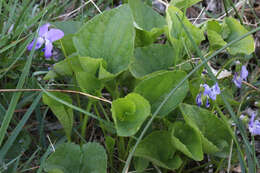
180, 104, 232, 157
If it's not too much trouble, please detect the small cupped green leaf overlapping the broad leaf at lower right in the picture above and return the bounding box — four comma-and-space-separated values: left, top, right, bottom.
172, 122, 203, 161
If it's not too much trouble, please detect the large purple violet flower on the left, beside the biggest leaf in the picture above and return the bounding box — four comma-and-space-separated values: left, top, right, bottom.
27, 23, 64, 59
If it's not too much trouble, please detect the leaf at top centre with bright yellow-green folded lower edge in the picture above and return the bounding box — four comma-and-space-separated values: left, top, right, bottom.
128, 0, 166, 47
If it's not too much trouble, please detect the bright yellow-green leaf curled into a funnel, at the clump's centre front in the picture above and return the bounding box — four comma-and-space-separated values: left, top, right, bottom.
111, 93, 151, 136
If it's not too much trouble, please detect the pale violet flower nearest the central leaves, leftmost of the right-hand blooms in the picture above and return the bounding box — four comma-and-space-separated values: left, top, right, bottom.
196, 83, 221, 108
